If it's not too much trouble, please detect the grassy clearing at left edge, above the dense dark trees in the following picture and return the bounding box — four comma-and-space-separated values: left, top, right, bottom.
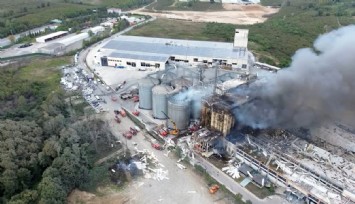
0, 56, 71, 119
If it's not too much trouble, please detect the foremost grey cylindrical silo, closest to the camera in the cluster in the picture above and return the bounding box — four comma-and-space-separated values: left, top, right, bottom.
168, 94, 190, 130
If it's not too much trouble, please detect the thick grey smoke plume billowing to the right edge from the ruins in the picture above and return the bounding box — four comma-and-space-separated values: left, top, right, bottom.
236, 26, 355, 128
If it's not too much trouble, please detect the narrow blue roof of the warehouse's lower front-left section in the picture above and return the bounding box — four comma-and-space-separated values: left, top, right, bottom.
108, 52, 169, 62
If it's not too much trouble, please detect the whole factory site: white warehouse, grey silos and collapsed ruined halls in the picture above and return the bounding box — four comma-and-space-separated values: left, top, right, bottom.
80, 24, 355, 203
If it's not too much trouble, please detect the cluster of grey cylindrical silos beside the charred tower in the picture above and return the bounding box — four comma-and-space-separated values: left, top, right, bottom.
139, 75, 206, 130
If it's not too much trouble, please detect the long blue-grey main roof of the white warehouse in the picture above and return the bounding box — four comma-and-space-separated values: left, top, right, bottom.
103, 36, 247, 59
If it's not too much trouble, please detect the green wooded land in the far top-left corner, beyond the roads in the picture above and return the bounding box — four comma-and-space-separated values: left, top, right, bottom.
0, 0, 152, 38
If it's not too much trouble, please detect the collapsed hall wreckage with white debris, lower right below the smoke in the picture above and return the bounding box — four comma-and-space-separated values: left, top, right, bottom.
236, 131, 355, 203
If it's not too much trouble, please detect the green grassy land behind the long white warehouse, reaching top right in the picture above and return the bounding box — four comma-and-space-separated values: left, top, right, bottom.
127, 0, 355, 67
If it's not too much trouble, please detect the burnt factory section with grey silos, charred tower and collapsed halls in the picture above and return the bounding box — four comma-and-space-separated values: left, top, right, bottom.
129, 62, 355, 203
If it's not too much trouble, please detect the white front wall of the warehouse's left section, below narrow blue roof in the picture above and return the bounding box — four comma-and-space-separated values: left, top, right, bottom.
107, 57, 165, 70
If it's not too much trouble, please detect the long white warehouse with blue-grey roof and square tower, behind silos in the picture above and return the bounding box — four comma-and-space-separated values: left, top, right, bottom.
100, 29, 249, 71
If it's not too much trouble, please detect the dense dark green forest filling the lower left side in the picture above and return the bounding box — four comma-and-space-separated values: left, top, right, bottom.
0, 59, 114, 204
